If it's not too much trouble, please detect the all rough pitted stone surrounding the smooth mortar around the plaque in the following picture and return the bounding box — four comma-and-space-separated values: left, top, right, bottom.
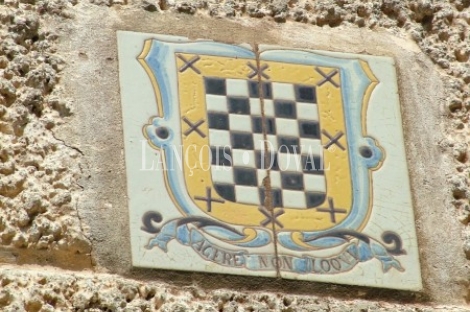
0, 0, 470, 312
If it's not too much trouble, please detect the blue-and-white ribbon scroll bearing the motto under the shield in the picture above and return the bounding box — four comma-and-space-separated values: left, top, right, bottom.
146, 219, 404, 274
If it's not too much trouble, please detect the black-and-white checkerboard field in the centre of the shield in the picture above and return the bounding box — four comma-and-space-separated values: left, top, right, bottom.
204, 77, 326, 209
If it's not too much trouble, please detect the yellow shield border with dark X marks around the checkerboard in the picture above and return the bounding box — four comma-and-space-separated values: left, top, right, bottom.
175, 53, 352, 231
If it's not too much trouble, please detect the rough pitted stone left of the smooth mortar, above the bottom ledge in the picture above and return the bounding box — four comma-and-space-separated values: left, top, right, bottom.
0, 1, 91, 266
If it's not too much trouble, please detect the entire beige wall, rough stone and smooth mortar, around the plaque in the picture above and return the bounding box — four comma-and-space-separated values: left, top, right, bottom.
0, 0, 470, 311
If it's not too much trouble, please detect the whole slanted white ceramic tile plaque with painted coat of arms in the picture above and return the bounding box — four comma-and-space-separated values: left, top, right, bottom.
117, 32, 422, 290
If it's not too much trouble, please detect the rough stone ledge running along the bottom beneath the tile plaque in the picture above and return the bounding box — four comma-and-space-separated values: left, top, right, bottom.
0, 267, 470, 312
